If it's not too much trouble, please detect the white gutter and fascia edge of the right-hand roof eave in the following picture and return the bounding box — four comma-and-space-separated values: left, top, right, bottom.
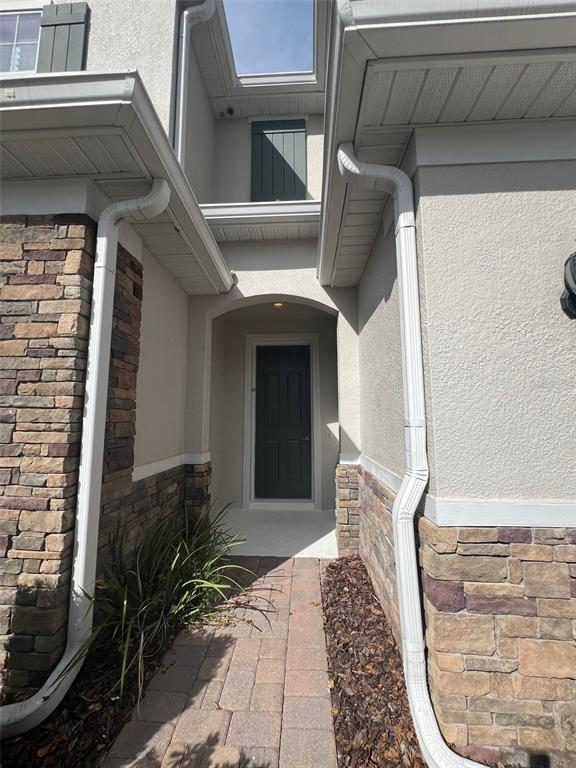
317, 5, 576, 286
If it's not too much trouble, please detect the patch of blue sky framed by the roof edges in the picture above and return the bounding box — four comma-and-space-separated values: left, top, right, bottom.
224, 0, 314, 75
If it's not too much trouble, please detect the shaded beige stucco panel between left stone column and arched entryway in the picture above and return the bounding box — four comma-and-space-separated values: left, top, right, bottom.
134, 249, 189, 467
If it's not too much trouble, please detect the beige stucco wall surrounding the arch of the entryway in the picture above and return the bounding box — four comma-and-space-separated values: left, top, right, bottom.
186, 240, 360, 468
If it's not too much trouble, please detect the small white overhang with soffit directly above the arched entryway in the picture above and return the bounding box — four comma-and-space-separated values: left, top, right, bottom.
200, 200, 321, 242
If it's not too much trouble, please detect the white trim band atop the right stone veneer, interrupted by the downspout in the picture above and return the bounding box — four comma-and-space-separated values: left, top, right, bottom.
340, 454, 576, 528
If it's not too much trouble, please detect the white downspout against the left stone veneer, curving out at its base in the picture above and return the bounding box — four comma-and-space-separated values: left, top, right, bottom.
0, 179, 170, 738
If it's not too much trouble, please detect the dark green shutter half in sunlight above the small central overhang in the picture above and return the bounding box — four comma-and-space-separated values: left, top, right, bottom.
251, 120, 306, 203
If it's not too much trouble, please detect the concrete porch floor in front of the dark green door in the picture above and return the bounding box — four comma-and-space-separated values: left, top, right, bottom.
220, 508, 338, 559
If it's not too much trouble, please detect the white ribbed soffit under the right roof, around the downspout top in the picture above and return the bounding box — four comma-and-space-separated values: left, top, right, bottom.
331, 50, 576, 287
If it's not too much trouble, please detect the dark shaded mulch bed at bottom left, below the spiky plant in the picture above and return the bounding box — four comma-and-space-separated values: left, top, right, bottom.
0, 637, 173, 768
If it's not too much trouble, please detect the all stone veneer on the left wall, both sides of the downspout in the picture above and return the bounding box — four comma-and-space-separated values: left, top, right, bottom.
0, 216, 210, 699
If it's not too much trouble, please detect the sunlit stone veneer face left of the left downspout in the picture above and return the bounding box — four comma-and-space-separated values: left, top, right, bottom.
0, 216, 95, 696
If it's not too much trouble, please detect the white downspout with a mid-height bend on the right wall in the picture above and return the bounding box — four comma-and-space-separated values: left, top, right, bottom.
338, 143, 481, 768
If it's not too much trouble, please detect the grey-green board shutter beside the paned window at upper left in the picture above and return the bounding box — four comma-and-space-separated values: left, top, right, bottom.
36, 3, 88, 72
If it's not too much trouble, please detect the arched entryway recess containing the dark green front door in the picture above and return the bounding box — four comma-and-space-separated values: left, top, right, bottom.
206, 295, 340, 556
